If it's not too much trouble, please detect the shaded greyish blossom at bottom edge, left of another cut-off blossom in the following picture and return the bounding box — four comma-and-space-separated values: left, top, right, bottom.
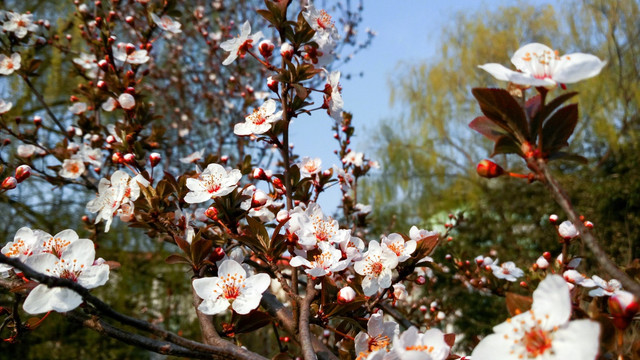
354, 312, 400, 358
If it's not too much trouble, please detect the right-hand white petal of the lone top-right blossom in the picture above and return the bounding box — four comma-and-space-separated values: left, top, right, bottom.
553, 53, 607, 84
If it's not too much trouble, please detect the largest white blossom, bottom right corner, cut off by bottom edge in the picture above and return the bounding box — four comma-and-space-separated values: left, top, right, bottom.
471, 275, 600, 360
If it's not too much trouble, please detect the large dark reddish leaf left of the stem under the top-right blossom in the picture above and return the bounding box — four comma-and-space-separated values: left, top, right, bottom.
472, 88, 529, 142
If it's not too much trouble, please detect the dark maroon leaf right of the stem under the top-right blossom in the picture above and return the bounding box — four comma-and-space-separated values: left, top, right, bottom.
541, 104, 578, 154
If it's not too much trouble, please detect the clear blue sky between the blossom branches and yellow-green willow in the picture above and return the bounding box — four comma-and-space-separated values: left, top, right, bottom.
291, 0, 558, 213
